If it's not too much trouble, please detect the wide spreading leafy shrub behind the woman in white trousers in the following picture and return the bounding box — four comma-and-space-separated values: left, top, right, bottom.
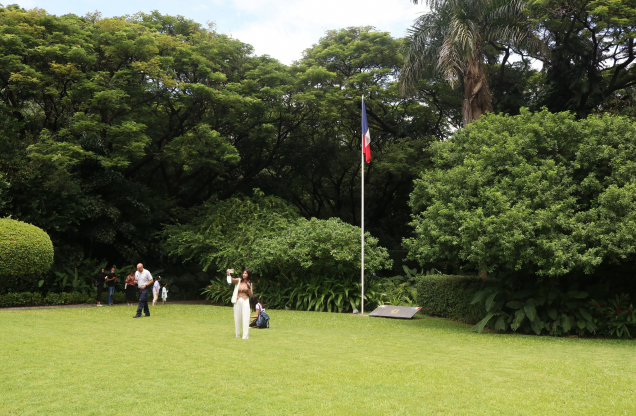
161, 189, 392, 282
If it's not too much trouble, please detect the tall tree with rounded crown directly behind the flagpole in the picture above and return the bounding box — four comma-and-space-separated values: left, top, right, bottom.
257, 27, 461, 247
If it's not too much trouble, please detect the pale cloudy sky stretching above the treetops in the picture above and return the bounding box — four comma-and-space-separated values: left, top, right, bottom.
13, 0, 426, 64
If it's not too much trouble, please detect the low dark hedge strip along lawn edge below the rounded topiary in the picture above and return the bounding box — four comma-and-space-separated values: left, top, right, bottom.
0, 292, 126, 308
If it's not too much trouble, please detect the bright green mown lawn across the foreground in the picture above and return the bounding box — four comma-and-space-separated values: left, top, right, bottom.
0, 305, 636, 415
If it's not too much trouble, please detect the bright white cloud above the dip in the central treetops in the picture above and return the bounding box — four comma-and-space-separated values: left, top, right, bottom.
225, 0, 425, 64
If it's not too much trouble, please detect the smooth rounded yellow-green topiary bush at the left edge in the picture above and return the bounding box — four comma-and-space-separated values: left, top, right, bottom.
0, 218, 53, 276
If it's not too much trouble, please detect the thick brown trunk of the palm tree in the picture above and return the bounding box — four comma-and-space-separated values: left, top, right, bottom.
463, 58, 492, 126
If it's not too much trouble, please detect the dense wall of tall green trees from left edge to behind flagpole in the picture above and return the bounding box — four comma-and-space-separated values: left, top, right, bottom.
0, 6, 450, 286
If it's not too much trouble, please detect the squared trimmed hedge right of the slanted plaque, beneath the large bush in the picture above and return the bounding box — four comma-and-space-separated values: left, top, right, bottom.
417, 275, 499, 325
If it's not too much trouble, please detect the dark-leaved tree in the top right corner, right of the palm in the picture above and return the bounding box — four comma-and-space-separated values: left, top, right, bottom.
529, 0, 636, 117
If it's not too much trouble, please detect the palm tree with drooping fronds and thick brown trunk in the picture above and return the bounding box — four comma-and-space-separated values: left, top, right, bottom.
400, 0, 545, 125
